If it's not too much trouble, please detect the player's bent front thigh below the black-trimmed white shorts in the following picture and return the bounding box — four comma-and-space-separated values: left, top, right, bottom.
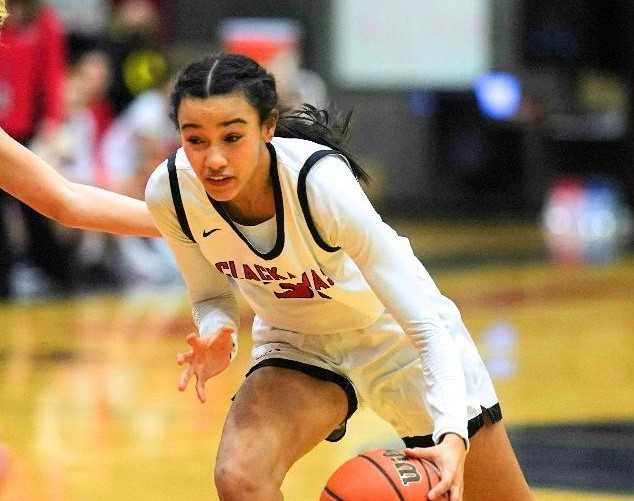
218, 367, 348, 478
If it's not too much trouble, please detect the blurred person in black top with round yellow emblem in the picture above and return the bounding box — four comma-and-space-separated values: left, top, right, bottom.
110, 0, 168, 113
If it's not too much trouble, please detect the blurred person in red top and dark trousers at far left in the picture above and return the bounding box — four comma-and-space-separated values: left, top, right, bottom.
0, 0, 74, 298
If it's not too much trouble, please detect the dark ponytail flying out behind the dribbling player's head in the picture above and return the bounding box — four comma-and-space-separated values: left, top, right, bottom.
275, 104, 370, 184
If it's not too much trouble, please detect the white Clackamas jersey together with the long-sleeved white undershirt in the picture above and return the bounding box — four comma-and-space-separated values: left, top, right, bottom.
146, 138, 495, 439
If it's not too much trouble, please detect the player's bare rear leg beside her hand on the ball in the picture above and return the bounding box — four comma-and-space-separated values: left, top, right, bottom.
464, 420, 534, 501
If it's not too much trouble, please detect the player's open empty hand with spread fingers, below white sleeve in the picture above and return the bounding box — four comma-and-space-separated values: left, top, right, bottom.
176, 327, 233, 403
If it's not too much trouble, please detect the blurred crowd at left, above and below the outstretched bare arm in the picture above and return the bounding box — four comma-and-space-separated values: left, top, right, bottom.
0, 0, 178, 300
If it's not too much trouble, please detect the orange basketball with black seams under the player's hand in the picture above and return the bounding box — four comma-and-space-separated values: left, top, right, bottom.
319, 449, 449, 501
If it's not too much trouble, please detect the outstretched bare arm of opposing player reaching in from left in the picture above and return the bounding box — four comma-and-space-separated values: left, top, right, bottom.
0, 129, 160, 236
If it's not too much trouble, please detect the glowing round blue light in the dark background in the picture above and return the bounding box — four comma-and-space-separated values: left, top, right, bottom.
474, 73, 522, 120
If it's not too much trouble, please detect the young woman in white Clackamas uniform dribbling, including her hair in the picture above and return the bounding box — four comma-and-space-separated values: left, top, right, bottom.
146, 54, 531, 501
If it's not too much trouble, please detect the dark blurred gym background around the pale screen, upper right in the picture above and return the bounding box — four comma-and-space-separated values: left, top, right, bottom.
162, 0, 634, 217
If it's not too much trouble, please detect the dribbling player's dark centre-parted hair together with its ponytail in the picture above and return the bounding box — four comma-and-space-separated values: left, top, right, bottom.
171, 53, 369, 183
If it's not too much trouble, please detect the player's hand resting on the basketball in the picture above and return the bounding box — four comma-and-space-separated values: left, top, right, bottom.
405, 433, 467, 501
